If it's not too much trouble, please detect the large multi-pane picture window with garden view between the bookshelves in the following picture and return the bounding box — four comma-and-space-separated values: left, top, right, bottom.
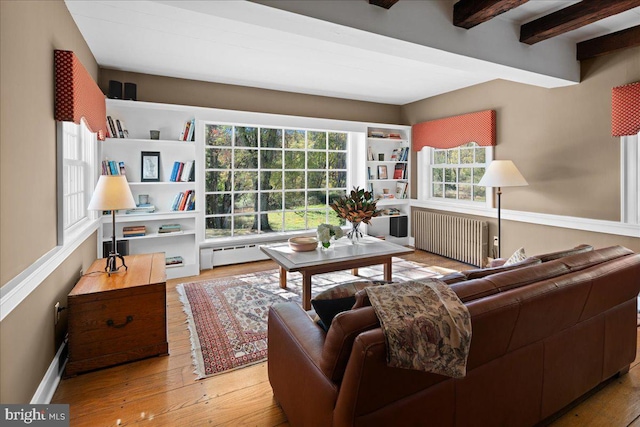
204, 123, 349, 239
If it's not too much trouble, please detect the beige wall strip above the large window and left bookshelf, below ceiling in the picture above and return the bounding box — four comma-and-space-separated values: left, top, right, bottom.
98, 68, 400, 123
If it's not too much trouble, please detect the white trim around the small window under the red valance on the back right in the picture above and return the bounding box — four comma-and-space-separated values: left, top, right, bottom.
416, 147, 494, 211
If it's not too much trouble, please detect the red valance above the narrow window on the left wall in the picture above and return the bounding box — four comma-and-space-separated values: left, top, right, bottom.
54, 50, 107, 140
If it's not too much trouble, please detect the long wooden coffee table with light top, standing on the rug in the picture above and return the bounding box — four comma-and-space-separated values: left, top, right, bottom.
260, 236, 413, 310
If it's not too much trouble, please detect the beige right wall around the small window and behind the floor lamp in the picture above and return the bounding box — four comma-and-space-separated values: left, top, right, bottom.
402, 47, 640, 255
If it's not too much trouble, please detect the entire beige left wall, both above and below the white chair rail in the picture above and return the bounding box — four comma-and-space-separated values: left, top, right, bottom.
0, 0, 98, 403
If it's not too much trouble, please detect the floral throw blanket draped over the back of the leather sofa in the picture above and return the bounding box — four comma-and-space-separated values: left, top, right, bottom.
366, 279, 471, 378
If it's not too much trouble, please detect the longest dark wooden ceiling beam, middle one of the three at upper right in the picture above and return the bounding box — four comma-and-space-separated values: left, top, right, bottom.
520, 0, 640, 44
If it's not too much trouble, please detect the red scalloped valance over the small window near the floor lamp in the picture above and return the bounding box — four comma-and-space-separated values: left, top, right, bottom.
411, 110, 496, 151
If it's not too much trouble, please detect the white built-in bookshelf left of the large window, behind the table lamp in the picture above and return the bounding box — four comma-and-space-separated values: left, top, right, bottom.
98, 99, 202, 278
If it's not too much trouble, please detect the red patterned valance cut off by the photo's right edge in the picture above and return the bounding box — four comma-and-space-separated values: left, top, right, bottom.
611, 82, 640, 136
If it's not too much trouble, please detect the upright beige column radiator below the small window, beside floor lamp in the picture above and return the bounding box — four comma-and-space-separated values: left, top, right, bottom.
413, 210, 489, 267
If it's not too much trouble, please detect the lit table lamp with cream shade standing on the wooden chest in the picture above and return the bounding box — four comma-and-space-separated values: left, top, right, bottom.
87, 175, 136, 275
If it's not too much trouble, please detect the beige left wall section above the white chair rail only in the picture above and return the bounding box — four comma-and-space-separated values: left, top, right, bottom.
0, 0, 98, 286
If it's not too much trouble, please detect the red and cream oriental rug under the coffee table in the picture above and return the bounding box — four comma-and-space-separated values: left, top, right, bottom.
176, 258, 453, 379
